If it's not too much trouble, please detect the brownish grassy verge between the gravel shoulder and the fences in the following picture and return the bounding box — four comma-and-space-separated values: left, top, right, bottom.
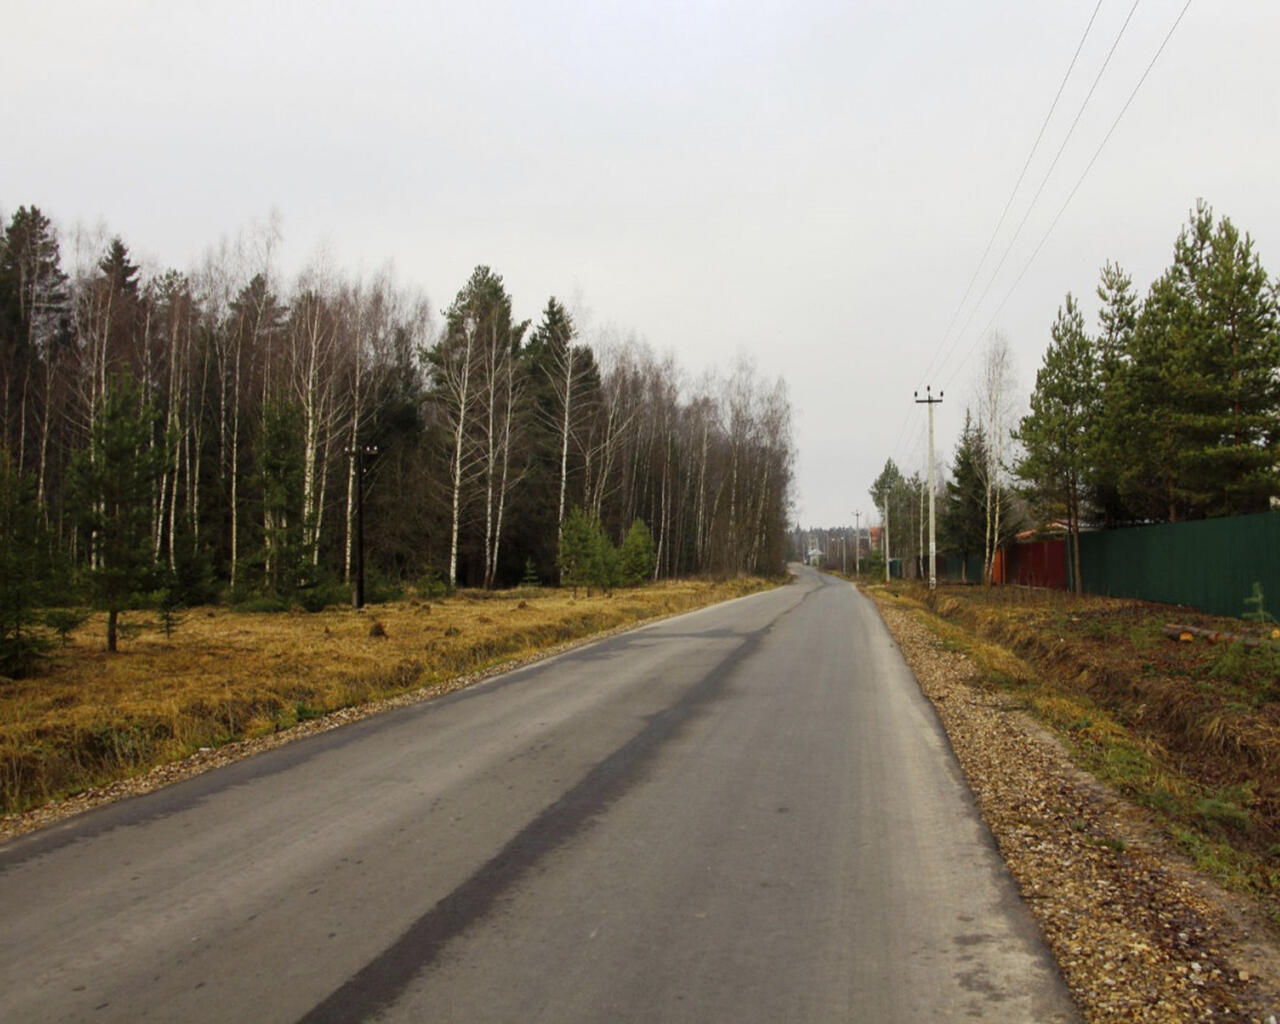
869, 582, 1280, 918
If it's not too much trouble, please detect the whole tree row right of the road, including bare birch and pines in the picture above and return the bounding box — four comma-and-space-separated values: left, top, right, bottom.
870, 204, 1280, 586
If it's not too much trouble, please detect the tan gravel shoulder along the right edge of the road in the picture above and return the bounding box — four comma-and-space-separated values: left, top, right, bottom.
877, 602, 1280, 1024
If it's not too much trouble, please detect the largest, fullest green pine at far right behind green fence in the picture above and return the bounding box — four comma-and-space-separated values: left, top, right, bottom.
1102, 205, 1280, 521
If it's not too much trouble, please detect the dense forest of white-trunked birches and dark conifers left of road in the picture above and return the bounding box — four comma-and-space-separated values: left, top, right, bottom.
0, 207, 792, 660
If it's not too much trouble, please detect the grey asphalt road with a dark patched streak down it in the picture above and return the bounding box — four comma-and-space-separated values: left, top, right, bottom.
0, 570, 1075, 1023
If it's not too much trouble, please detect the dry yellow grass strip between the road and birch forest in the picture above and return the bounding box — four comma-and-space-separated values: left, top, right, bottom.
0, 579, 769, 813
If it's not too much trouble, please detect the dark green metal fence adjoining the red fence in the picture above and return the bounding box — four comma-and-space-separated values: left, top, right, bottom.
1068, 512, 1280, 616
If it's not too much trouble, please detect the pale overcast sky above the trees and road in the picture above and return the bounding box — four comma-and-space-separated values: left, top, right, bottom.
0, 0, 1280, 525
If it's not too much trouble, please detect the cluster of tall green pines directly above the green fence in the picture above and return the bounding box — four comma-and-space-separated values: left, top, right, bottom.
1015, 204, 1280, 585
